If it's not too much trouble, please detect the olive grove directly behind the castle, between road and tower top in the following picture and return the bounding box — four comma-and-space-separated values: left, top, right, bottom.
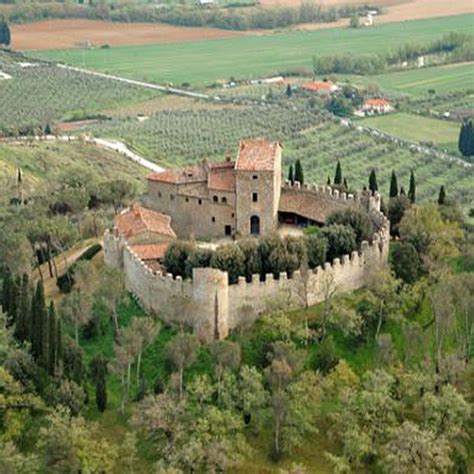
84, 102, 322, 166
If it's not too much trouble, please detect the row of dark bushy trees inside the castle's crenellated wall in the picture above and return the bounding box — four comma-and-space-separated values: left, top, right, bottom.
163, 206, 374, 283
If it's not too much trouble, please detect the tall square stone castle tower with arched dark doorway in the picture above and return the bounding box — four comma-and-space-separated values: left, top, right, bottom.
235, 138, 281, 235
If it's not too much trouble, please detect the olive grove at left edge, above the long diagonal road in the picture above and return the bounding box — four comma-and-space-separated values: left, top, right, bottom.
0, 53, 160, 133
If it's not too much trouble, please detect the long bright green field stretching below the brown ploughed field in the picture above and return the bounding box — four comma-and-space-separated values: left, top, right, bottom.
31, 15, 474, 85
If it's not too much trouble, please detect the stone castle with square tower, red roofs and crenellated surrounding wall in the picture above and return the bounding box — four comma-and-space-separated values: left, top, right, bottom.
104, 139, 390, 340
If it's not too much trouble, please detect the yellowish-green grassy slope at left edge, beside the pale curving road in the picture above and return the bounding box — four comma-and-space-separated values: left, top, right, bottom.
0, 142, 147, 201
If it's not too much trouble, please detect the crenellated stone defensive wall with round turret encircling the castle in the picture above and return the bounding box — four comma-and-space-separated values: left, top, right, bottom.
104, 186, 390, 341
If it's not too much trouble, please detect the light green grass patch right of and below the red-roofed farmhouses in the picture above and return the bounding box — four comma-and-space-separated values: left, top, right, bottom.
361, 113, 459, 145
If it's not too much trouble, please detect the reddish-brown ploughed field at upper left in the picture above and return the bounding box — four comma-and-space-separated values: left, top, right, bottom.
11, 20, 244, 50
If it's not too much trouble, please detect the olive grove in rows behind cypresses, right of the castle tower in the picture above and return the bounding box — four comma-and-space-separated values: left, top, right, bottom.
284, 122, 474, 218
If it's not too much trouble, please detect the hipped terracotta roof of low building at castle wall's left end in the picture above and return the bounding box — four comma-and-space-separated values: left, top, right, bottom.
115, 203, 176, 238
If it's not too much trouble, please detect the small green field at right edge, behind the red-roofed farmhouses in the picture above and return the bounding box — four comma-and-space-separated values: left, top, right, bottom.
344, 63, 474, 97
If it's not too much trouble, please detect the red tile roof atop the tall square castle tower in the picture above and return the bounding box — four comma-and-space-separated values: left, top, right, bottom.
235, 138, 281, 171
